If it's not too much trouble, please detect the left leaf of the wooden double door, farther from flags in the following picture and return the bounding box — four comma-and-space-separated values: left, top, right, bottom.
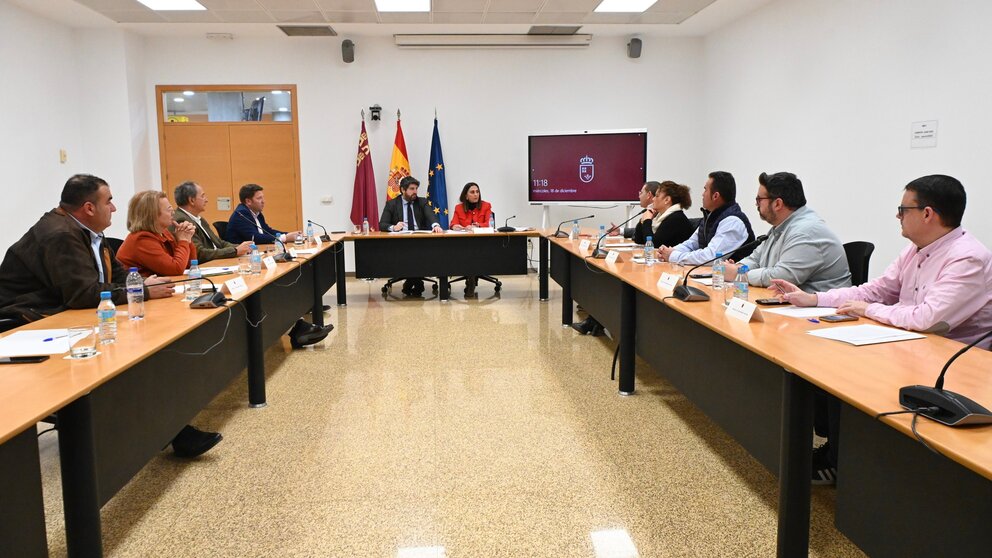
162, 124, 238, 228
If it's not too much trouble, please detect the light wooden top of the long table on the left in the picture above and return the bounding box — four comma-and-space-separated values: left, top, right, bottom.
0, 243, 333, 443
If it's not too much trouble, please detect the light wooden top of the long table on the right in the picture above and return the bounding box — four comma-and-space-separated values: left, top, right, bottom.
551, 239, 992, 479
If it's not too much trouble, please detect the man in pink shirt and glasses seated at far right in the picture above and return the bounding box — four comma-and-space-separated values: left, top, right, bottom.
771, 174, 992, 484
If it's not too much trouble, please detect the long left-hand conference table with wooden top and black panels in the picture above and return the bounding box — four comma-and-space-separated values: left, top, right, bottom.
0, 242, 338, 556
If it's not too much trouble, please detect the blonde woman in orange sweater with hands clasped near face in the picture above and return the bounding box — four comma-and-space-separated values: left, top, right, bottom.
117, 190, 196, 277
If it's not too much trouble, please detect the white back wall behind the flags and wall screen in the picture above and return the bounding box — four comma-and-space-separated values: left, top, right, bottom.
145, 37, 702, 238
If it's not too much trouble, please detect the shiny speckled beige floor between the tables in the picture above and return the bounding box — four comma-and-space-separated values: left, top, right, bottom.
42, 274, 862, 558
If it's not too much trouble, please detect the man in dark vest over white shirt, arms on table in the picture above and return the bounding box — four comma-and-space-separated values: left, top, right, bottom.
658, 171, 754, 265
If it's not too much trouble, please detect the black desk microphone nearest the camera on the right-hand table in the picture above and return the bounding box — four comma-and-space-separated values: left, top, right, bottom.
899, 331, 992, 426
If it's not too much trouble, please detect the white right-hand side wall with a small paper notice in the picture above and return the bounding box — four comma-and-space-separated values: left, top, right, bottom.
703, 0, 992, 276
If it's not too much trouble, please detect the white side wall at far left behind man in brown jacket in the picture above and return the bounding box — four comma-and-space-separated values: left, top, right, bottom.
0, 1, 86, 251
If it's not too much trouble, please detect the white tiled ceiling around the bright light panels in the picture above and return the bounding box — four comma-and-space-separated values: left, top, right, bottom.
10, 0, 770, 35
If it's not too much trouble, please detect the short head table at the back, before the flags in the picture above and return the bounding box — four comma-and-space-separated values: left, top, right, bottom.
337, 230, 548, 305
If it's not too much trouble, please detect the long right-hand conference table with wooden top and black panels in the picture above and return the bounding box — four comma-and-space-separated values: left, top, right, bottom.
550, 239, 992, 557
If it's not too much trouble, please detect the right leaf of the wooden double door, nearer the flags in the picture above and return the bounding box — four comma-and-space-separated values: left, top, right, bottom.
230, 124, 302, 231
